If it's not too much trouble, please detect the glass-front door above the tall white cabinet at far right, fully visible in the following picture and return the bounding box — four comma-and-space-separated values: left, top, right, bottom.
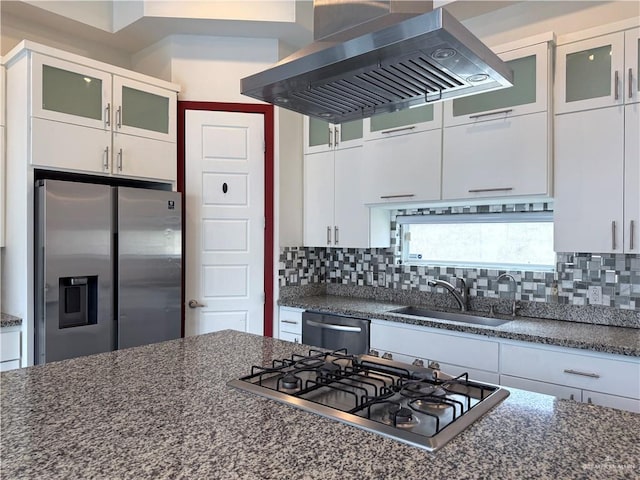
555, 32, 624, 113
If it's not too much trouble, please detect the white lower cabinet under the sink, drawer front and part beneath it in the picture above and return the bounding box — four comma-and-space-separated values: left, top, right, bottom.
371, 320, 500, 376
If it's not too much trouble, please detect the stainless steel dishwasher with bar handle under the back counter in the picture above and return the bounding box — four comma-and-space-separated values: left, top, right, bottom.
302, 311, 371, 355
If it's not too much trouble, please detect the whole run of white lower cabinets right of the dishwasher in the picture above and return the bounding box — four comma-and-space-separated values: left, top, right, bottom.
371, 320, 640, 413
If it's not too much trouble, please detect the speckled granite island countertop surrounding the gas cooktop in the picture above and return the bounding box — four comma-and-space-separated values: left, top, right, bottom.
0, 331, 640, 480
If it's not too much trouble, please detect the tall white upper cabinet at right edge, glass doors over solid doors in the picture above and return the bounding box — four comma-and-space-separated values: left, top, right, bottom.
554, 24, 640, 253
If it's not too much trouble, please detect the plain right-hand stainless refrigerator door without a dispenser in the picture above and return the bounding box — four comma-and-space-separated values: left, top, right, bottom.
116, 187, 182, 349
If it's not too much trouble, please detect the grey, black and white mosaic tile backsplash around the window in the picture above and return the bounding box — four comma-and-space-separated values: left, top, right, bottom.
279, 203, 640, 311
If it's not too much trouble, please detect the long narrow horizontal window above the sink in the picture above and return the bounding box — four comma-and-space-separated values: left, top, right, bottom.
397, 212, 556, 270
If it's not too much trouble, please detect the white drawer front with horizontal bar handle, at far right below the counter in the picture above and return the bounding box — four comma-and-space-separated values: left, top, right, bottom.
500, 344, 640, 398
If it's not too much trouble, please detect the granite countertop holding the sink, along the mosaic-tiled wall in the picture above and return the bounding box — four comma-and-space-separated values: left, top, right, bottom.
279, 295, 640, 356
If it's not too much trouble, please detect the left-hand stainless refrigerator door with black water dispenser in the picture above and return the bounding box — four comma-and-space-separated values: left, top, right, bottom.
35, 180, 115, 363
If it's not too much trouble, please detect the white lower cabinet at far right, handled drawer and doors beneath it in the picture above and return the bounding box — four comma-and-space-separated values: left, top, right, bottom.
500, 343, 640, 413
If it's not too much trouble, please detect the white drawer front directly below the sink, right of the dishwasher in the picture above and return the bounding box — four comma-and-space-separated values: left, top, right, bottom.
371, 323, 499, 372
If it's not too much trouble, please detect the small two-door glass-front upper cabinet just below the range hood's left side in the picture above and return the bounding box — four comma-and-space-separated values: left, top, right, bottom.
304, 116, 364, 153
